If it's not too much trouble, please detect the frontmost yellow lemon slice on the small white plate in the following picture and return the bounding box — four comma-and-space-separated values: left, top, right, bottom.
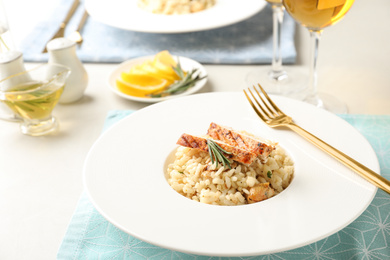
116, 73, 169, 97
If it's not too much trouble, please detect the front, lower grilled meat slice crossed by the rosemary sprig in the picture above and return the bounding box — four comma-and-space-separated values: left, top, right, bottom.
177, 134, 257, 165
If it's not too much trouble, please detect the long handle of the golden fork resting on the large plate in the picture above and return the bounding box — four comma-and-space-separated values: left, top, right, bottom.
287, 123, 390, 194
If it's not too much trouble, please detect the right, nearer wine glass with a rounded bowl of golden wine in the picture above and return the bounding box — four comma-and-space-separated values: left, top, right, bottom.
283, 0, 355, 114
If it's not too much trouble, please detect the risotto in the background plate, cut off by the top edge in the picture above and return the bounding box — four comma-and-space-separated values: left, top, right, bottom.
138, 0, 215, 15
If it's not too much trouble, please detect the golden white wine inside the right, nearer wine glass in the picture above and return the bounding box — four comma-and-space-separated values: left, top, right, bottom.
283, 0, 355, 31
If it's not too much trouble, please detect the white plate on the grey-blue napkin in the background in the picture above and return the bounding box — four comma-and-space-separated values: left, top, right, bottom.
85, 0, 266, 33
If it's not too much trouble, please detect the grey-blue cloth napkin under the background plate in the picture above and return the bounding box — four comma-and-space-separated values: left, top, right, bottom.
19, 0, 296, 64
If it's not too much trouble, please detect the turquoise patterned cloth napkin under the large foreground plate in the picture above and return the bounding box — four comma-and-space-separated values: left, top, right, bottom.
57, 110, 390, 260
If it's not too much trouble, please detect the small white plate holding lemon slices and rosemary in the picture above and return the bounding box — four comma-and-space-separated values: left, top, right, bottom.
107, 56, 207, 103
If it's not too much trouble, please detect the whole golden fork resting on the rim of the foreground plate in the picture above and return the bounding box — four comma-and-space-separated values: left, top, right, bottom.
244, 84, 390, 194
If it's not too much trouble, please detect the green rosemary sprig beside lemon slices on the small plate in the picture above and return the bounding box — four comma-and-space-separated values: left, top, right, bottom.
150, 61, 207, 97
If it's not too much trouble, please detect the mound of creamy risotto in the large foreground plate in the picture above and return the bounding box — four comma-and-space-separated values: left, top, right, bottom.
166, 123, 294, 205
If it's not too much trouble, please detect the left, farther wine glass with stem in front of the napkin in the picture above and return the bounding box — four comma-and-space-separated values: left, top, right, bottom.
245, 0, 307, 98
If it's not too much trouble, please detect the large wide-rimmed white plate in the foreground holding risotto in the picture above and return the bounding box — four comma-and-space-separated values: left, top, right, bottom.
84, 92, 379, 256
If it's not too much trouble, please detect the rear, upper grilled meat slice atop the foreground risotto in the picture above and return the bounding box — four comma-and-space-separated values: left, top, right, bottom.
207, 123, 275, 163
